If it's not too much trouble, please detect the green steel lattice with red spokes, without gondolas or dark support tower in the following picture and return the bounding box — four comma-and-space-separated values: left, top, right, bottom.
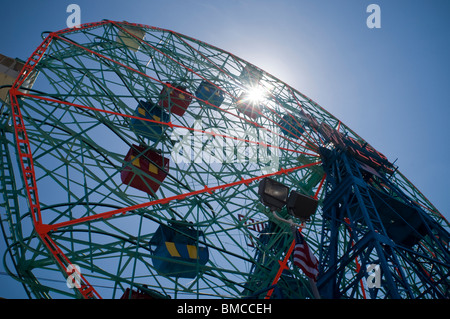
0, 20, 449, 298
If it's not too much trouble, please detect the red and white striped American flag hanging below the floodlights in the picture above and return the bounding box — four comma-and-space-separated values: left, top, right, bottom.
294, 231, 319, 281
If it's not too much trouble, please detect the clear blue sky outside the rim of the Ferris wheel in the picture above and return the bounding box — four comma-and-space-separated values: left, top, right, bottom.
0, 0, 450, 297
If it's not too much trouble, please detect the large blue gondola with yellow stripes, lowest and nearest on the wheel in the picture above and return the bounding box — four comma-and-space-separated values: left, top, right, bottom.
149, 223, 209, 278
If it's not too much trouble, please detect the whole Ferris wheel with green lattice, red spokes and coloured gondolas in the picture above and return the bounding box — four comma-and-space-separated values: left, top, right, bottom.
0, 20, 450, 299
